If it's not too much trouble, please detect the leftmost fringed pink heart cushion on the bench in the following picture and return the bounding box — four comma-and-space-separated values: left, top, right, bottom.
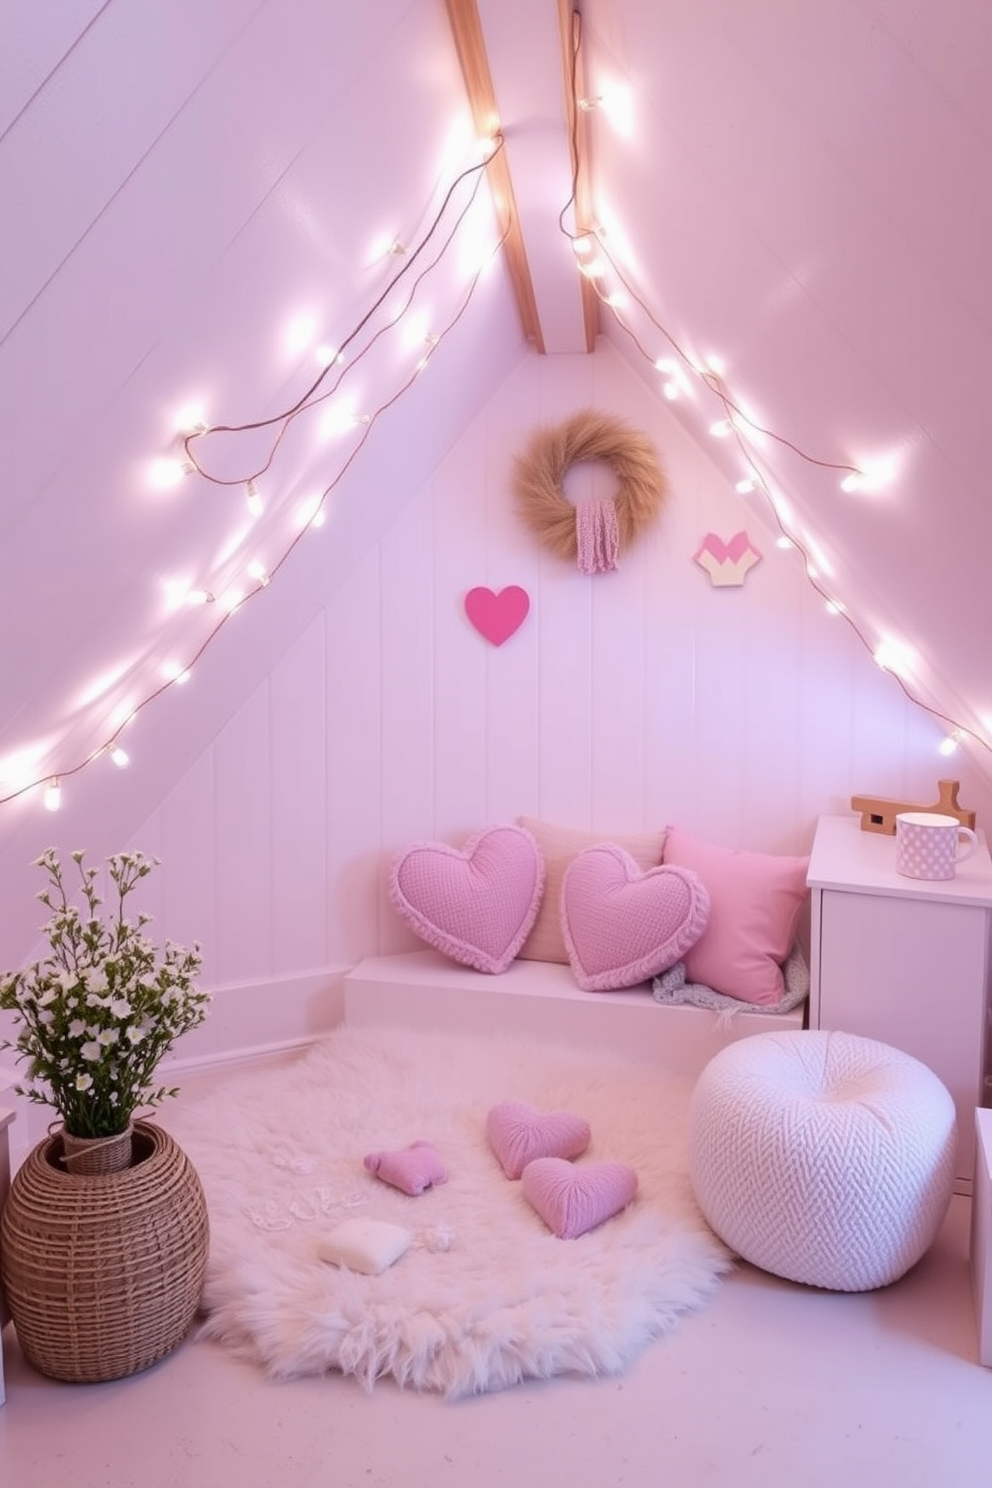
390, 826, 544, 973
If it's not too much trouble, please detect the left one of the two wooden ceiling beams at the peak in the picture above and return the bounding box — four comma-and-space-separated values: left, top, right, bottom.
445, 0, 544, 353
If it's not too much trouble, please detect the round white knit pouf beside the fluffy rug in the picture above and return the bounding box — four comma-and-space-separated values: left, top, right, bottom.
689, 1030, 956, 1292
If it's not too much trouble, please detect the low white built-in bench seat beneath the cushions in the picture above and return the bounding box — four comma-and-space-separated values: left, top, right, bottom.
344, 951, 803, 1076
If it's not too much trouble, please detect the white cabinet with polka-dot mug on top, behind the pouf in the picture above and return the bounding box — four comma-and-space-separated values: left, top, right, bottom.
808, 817, 992, 1193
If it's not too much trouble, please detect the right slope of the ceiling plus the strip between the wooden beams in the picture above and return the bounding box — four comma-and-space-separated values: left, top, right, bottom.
482, 0, 992, 771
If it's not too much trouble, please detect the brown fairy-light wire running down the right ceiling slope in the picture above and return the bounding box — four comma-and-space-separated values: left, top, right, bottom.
558, 10, 992, 754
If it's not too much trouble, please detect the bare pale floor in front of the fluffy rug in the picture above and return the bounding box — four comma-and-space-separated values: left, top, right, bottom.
0, 1077, 992, 1488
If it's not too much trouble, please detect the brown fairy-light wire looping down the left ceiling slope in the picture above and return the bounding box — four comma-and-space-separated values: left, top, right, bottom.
0, 134, 512, 805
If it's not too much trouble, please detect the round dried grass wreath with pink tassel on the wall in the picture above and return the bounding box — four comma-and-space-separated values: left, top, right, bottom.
513, 409, 668, 573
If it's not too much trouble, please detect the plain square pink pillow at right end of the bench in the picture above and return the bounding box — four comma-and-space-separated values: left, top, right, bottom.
665, 827, 809, 1007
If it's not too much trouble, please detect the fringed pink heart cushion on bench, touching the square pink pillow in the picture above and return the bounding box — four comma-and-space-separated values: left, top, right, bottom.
561, 842, 709, 992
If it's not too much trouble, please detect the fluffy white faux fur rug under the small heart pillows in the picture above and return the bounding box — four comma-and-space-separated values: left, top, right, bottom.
164, 1027, 732, 1399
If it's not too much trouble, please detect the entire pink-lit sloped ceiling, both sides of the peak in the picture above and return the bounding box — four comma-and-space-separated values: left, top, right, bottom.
0, 0, 992, 850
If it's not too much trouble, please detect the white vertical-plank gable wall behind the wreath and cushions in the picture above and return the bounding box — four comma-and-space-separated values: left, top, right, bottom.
132, 337, 989, 1054
